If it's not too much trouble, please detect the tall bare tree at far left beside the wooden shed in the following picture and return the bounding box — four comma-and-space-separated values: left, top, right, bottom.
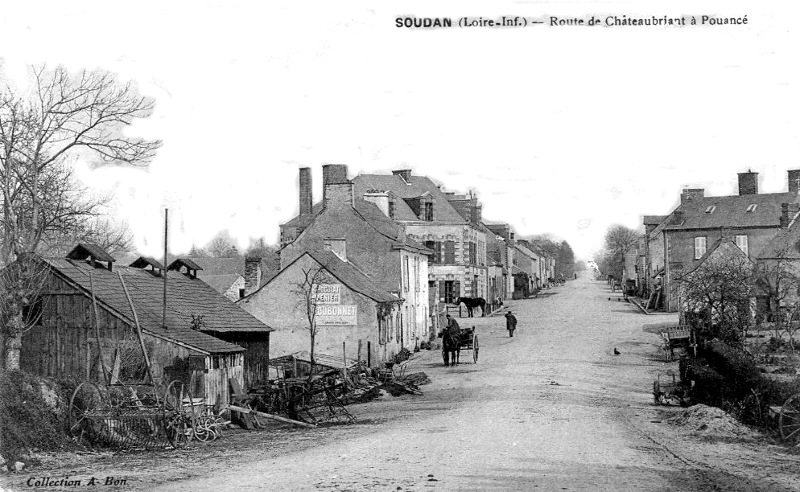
0, 66, 160, 369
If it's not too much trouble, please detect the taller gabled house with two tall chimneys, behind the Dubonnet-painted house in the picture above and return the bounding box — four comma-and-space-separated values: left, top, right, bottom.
280, 165, 435, 350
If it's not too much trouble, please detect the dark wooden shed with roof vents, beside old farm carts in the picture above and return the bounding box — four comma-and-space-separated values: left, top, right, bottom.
20, 244, 272, 403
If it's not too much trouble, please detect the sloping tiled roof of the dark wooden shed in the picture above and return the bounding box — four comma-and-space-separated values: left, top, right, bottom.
45, 258, 273, 353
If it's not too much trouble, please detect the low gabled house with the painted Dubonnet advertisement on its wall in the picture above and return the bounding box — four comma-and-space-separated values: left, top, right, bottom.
238, 251, 400, 361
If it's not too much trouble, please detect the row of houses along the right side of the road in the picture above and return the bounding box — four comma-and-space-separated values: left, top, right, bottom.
623, 170, 800, 311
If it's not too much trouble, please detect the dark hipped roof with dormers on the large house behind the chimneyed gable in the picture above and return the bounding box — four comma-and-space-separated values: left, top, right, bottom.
352, 174, 467, 224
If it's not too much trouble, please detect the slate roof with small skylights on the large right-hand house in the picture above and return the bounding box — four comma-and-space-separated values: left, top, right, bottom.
665, 193, 800, 230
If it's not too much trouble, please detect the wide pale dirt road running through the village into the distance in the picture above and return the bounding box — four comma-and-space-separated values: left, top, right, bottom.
3, 279, 800, 491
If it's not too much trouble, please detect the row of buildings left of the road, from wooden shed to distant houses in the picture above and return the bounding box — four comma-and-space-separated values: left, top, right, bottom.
21, 165, 555, 403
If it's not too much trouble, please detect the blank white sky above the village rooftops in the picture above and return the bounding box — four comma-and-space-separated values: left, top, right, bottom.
0, 0, 800, 257
